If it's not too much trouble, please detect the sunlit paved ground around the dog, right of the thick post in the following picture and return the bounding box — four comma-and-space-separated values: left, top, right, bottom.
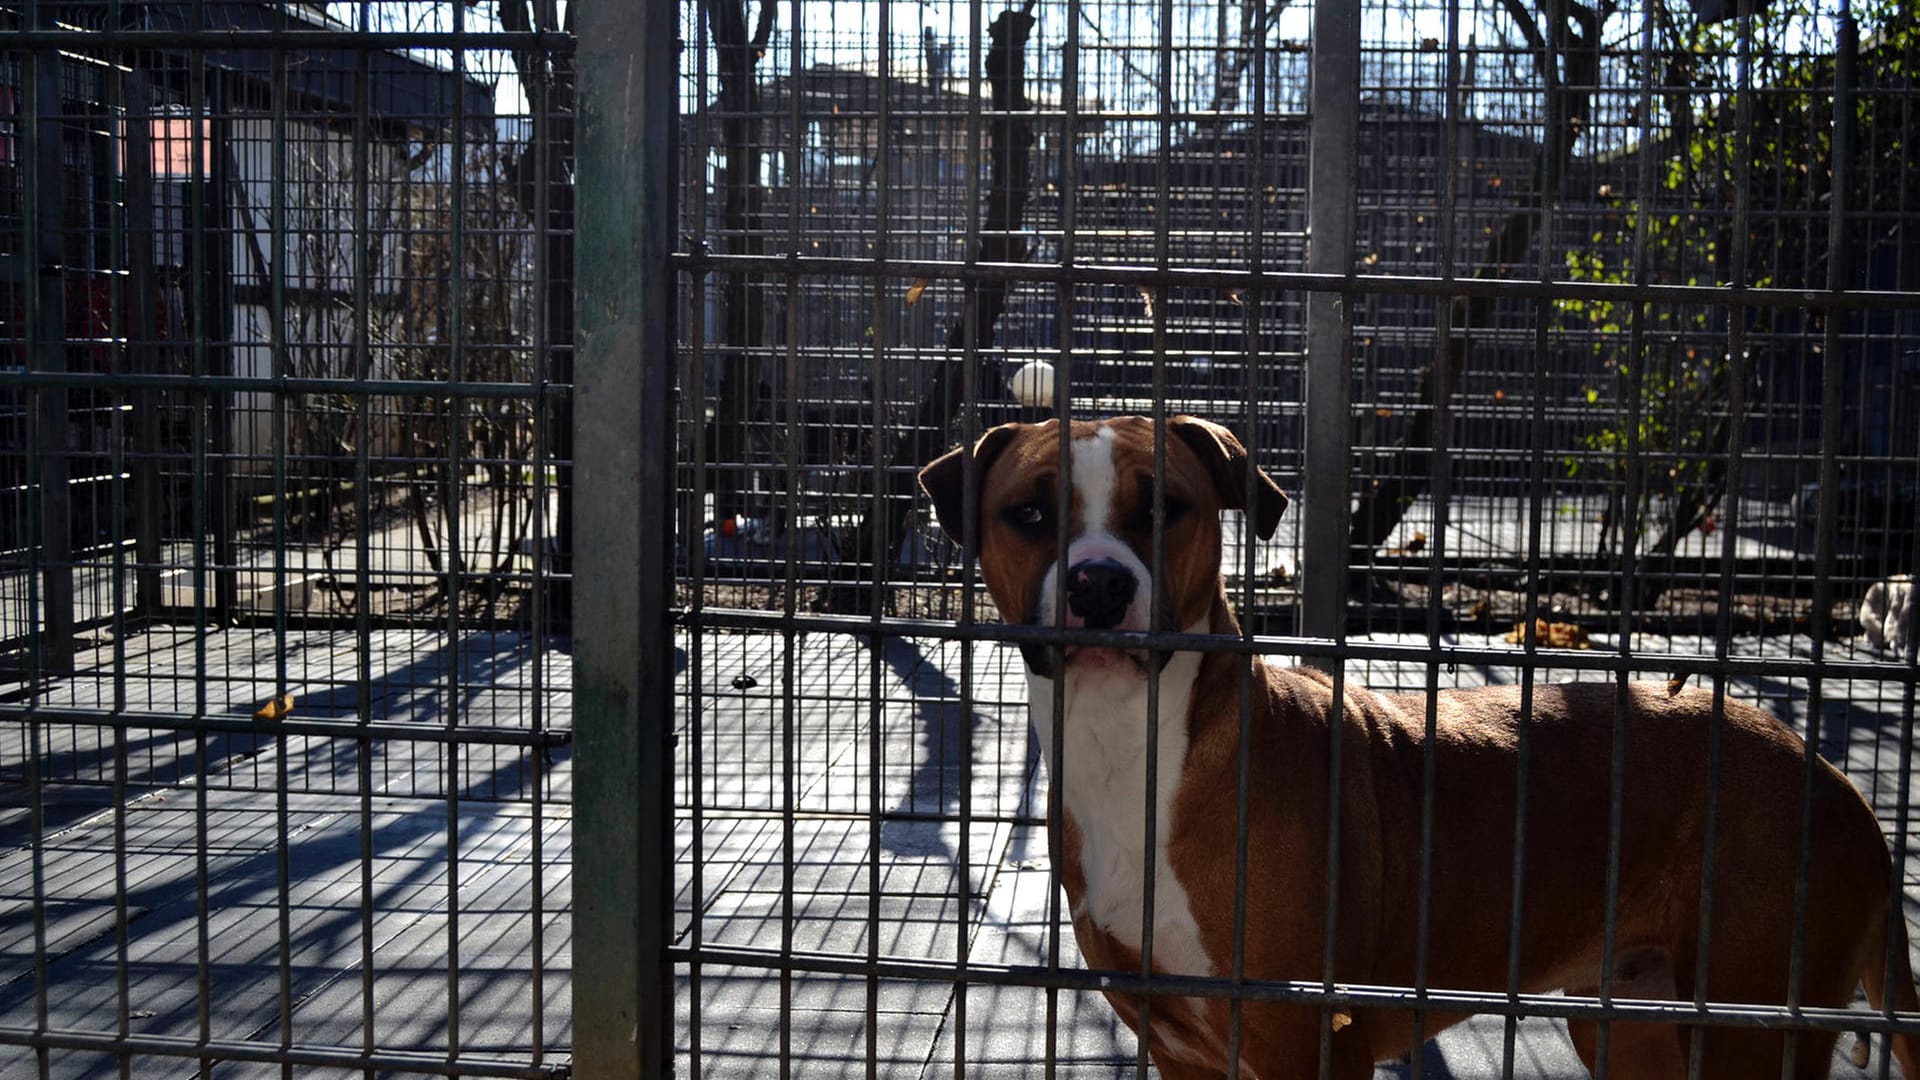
680, 622, 1920, 1078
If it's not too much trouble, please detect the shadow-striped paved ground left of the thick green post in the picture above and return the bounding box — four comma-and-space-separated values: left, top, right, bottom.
0, 630, 572, 1080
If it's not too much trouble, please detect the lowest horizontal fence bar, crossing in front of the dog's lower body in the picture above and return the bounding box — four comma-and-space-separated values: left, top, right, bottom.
668, 947, 1920, 1034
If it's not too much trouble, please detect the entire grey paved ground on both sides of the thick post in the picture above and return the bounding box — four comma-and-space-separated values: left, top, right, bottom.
0, 611, 1920, 1080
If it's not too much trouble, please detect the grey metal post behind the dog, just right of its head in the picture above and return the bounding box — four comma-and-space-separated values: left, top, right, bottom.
1300, 4, 1359, 645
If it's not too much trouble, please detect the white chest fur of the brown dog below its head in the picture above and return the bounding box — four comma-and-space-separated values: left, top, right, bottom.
1027, 653, 1212, 974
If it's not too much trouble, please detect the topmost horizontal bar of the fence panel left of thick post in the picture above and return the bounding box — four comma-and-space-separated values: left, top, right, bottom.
6, 27, 574, 56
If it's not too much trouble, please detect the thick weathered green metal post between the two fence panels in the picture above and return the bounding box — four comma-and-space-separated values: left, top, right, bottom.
574, 0, 680, 1078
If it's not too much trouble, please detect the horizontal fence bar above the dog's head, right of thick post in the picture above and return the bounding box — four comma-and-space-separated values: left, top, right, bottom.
674, 252, 1920, 311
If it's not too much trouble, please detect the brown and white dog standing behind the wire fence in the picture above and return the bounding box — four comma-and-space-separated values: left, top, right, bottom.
920, 417, 1920, 1080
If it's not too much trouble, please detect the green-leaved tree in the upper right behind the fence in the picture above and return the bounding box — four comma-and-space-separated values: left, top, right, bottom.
1559, 0, 1920, 607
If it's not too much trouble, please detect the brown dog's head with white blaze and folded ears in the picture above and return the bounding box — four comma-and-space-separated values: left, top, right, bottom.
920, 417, 1286, 675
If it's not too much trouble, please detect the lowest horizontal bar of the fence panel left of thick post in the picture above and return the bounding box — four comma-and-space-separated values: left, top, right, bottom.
0, 1024, 572, 1080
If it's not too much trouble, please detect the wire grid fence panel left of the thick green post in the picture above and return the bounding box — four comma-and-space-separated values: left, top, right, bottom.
0, 0, 572, 1076
